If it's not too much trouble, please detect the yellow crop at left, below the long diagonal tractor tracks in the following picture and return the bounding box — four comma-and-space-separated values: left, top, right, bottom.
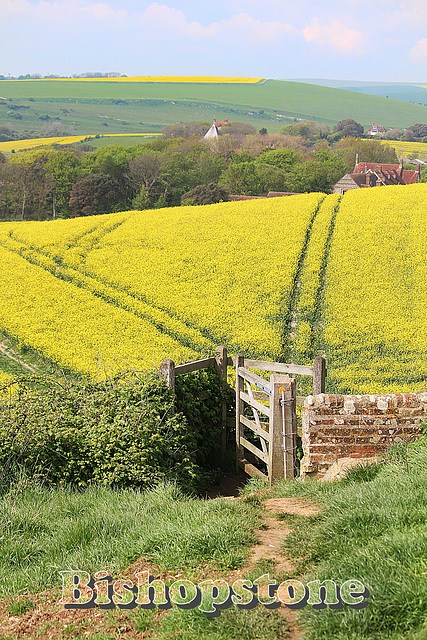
0, 247, 196, 376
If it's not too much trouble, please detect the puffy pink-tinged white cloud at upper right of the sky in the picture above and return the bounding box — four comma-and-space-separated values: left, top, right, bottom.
303, 18, 366, 55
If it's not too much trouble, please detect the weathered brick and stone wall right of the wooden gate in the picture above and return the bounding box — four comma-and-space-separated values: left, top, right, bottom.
301, 393, 427, 478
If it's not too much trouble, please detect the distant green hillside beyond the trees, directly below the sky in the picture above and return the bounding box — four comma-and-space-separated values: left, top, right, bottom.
0, 80, 427, 139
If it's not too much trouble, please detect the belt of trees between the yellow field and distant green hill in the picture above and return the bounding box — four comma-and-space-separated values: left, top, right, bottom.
0, 121, 408, 220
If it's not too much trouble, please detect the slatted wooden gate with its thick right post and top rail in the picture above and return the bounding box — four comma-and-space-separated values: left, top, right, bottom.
236, 355, 313, 484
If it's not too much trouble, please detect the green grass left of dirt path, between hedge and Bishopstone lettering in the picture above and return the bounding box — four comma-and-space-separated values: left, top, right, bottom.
0, 480, 258, 598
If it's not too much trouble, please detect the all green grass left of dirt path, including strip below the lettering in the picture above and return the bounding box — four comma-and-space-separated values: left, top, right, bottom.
0, 477, 286, 640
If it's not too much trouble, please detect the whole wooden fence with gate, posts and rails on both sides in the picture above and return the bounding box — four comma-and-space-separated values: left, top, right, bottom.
160, 346, 326, 483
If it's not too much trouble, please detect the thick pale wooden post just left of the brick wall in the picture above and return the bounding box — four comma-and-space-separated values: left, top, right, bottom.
268, 374, 296, 485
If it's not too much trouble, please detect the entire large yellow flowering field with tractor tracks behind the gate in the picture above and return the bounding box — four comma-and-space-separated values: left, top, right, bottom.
0, 184, 427, 393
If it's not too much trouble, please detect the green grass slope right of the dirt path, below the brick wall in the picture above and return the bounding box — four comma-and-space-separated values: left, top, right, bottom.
270, 440, 427, 640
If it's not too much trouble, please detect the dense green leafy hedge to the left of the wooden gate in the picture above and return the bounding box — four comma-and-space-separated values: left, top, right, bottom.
0, 373, 201, 490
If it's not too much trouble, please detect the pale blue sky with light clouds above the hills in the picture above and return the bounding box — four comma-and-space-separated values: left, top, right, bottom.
0, 0, 427, 84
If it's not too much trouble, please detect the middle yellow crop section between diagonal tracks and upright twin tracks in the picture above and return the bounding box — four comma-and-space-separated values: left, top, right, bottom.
81, 194, 322, 357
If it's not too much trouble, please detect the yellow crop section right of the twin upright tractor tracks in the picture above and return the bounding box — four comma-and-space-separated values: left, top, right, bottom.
323, 184, 427, 393
